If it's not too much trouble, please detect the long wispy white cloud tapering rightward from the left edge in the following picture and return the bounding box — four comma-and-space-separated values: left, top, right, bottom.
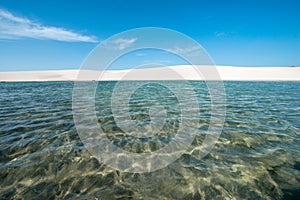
0, 9, 97, 42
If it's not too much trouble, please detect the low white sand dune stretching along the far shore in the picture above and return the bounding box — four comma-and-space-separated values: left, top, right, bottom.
0, 65, 300, 82
